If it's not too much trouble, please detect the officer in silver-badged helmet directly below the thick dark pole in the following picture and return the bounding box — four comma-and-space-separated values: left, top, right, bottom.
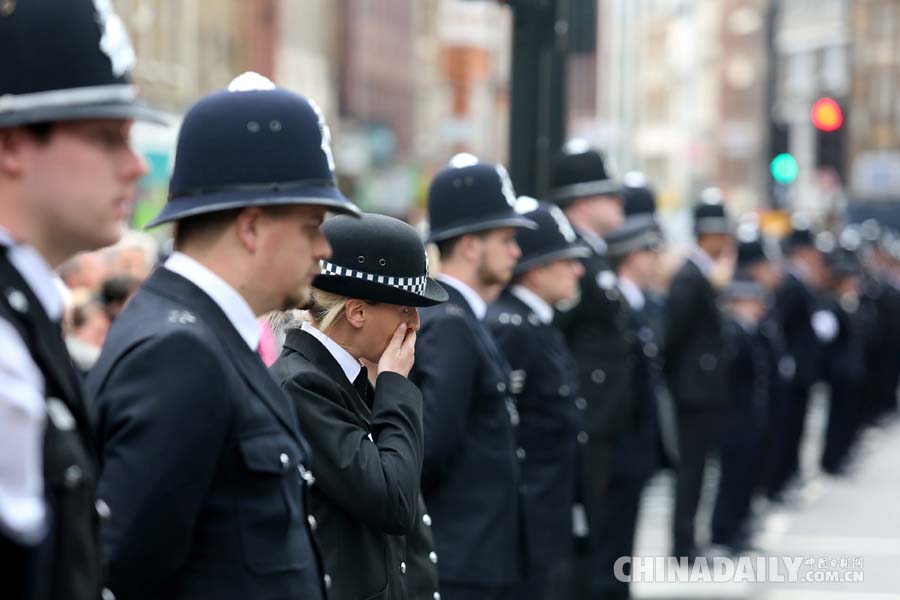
486, 197, 590, 600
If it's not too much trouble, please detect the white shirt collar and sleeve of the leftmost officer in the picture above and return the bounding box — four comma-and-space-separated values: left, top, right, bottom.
0, 229, 62, 545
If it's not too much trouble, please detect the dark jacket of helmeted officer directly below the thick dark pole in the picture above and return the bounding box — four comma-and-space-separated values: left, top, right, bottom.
485, 289, 585, 567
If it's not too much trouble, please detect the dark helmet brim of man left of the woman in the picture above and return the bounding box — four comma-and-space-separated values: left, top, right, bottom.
145, 186, 360, 229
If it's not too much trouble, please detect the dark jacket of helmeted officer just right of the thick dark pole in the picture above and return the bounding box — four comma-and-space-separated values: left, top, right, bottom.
555, 230, 636, 442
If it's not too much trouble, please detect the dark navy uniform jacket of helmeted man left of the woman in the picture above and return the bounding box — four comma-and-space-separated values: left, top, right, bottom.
88, 267, 325, 600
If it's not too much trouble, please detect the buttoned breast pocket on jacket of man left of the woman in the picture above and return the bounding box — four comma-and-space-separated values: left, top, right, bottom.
239, 432, 313, 574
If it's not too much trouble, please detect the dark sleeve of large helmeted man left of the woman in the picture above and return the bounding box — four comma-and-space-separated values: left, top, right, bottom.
96, 331, 230, 599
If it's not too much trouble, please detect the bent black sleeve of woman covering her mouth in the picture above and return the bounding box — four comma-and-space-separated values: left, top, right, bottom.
281, 371, 422, 535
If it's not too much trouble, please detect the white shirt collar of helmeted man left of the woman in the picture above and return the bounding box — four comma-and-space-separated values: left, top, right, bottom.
164, 252, 260, 352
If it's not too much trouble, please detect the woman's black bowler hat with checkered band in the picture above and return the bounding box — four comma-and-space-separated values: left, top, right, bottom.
313, 213, 448, 306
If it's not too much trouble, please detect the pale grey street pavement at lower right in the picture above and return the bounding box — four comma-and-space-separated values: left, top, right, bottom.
632, 391, 900, 600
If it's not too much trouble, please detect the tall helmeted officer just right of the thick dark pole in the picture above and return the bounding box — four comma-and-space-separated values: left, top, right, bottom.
550, 139, 635, 594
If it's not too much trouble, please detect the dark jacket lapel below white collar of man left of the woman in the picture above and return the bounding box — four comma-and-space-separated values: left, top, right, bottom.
145, 267, 306, 445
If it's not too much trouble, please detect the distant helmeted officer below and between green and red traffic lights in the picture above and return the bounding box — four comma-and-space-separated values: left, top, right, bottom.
767, 213, 827, 501
